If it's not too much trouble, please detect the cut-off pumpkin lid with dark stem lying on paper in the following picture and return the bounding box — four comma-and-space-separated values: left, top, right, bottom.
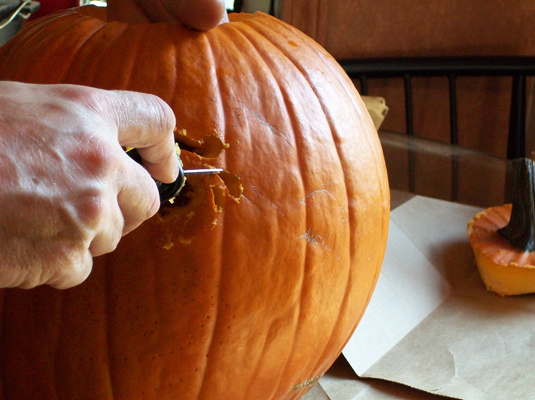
467, 158, 535, 296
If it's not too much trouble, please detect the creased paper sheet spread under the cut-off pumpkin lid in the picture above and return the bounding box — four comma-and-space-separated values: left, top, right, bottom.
338, 196, 535, 400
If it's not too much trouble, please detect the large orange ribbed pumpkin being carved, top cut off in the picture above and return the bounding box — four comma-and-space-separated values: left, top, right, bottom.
0, 7, 389, 400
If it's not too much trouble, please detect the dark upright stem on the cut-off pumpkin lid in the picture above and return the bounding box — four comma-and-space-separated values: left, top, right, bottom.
498, 158, 535, 252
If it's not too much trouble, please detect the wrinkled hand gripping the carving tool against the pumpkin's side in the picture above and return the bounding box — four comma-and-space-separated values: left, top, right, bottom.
0, 82, 178, 288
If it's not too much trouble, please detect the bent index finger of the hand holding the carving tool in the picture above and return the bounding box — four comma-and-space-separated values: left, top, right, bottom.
108, 91, 179, 183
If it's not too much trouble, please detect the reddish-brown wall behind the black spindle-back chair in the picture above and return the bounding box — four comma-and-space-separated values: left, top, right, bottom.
281, 0, 535, 156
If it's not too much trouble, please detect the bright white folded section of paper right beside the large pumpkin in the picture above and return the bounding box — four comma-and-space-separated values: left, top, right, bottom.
343, 221, 450, 375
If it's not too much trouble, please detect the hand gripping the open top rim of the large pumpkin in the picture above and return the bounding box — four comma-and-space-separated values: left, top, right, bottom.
107, 0, 225, 31
